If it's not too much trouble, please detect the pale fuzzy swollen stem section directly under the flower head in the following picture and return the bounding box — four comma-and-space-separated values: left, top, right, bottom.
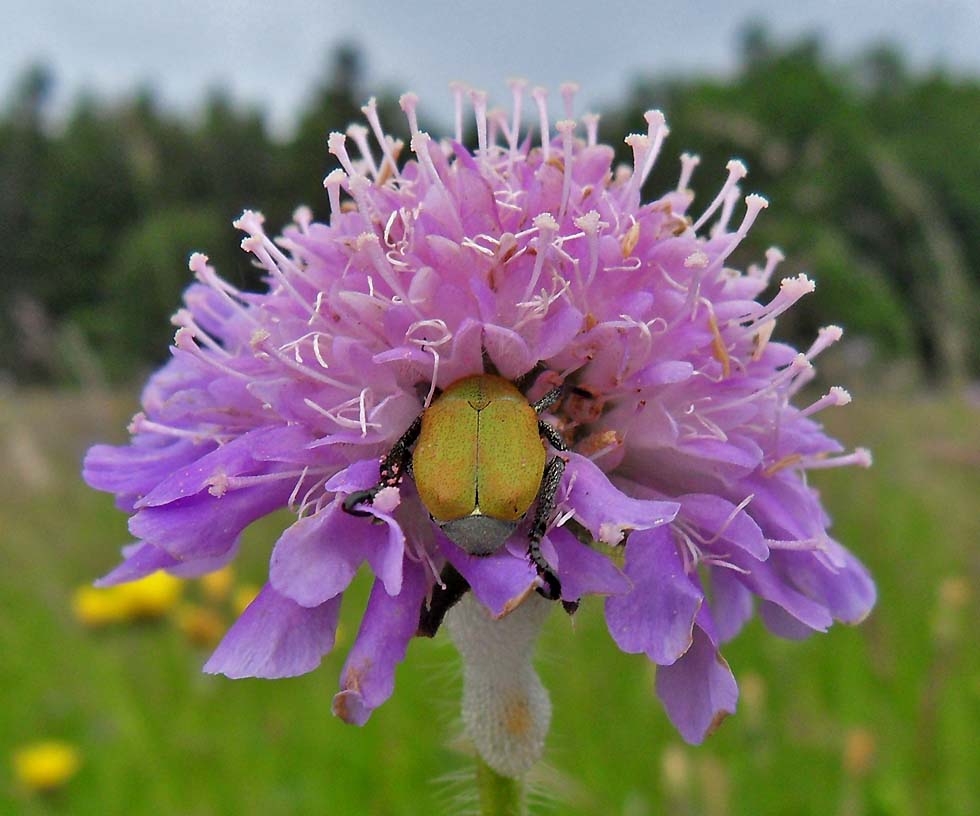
446, 593, 551, 777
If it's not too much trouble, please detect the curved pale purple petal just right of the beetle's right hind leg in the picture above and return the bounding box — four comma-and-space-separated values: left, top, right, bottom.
562, 452, 680, 544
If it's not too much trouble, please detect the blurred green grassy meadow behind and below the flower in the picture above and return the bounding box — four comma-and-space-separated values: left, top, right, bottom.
0, 392, 980, 816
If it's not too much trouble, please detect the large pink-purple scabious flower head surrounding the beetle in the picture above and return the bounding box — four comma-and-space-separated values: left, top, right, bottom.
85, 82, 875, 742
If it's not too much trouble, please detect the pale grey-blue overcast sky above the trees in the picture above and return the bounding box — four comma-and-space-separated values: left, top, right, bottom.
0, 0, 980, 128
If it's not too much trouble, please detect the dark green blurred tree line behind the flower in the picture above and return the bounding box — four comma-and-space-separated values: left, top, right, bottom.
0, 32, 980, 383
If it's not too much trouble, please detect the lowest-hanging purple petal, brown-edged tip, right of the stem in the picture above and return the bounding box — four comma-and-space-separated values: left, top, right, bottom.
656, 627, 738, 745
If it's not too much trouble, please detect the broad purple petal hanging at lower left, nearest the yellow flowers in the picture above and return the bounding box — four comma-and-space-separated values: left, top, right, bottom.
204, 584, 340, 679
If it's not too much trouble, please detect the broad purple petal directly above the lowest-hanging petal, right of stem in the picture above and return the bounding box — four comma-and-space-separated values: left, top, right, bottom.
606, 527, 704, 665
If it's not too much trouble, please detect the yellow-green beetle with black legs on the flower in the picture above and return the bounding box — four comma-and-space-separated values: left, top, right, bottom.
343, 374, 567, 608
